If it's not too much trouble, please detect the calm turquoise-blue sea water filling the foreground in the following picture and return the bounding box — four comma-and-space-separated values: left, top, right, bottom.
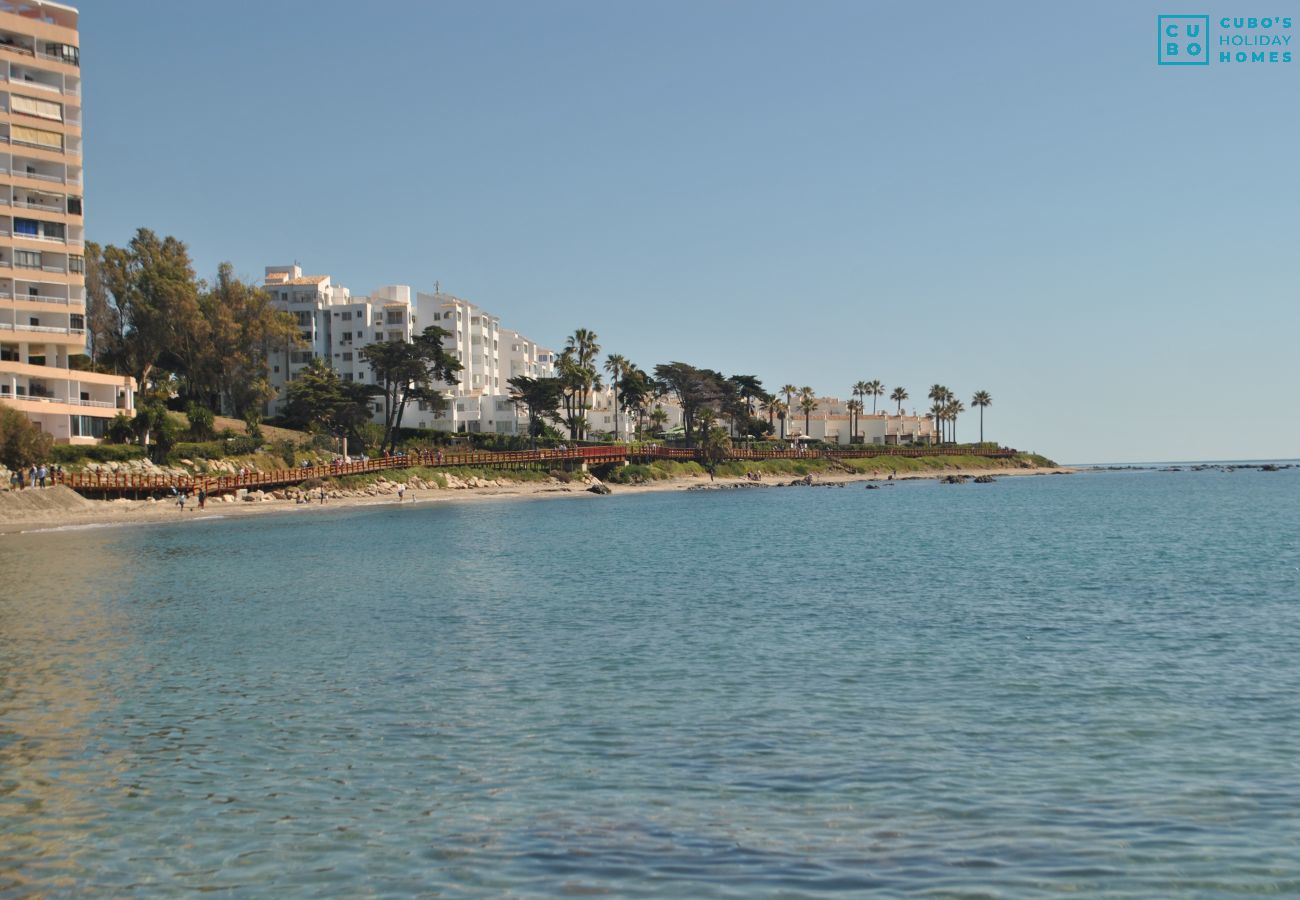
0, 470, 1300, 897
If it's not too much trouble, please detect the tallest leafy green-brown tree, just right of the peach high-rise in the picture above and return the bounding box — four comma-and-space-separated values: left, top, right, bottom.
96, 228, 204, 397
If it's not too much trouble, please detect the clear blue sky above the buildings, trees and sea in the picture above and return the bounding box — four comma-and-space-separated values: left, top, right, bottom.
81, 0, 1300, 462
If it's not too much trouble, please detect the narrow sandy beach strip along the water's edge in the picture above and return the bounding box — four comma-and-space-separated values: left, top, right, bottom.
0, 466, 1080, 536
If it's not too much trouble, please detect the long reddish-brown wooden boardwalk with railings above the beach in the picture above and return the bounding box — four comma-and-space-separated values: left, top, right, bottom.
55, 443, 1018, 497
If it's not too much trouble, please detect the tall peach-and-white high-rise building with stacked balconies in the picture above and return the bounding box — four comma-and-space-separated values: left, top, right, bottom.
0, 0, 135, 443
